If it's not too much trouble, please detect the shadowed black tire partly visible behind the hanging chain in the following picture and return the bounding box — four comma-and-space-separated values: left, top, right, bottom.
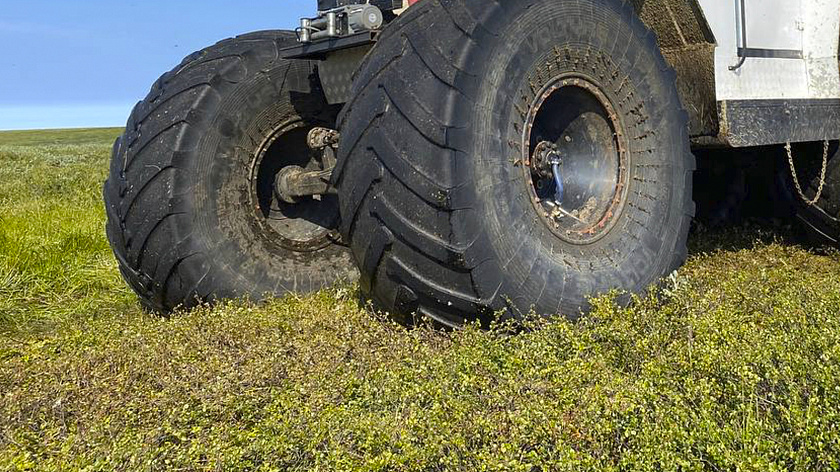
779, 141, 840, 246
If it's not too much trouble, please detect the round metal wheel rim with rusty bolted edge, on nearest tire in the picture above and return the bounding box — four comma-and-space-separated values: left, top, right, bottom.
522, 74, 628, 244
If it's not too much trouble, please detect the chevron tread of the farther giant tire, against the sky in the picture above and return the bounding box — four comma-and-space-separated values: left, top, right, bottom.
103, 31, 304, 312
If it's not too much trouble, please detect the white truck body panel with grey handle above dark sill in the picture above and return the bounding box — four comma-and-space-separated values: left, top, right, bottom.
699, 0, 840, 101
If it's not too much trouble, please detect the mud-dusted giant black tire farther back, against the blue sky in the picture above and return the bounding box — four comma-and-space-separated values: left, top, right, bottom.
104, 31, 355, 312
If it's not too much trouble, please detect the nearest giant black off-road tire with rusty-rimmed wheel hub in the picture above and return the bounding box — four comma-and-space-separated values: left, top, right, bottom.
334, 0, 694, 325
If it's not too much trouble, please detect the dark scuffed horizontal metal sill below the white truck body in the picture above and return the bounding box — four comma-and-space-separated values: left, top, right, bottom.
718, 98, 840, 147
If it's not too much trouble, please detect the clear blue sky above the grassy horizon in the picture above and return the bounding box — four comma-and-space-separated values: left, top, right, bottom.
0, 0, 317, 130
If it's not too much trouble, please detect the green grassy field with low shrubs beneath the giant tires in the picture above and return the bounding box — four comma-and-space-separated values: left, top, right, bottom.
0, 130, 840, 472
